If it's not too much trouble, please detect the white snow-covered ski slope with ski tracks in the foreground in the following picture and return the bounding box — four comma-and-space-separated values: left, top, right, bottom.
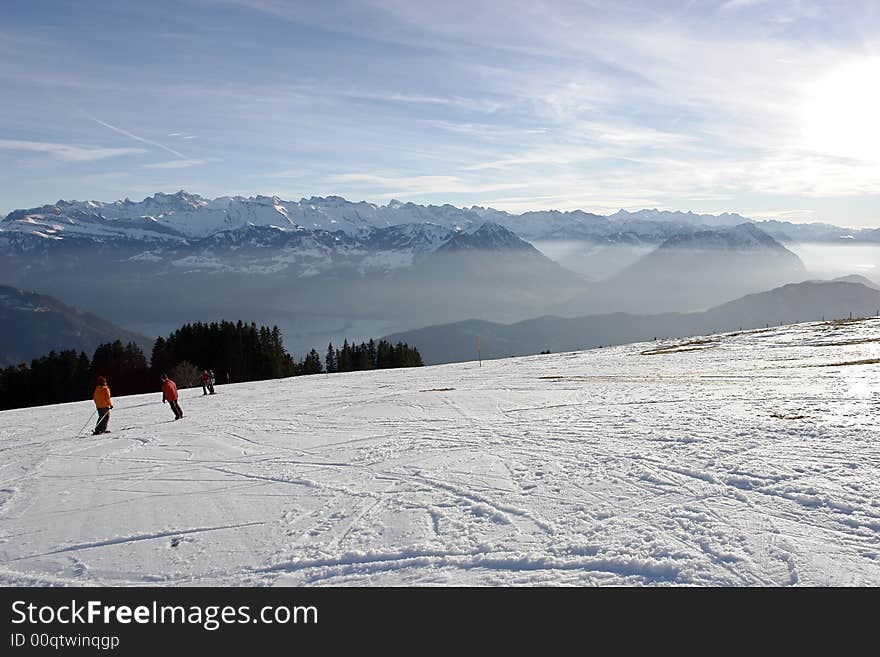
0, 319, 880, 586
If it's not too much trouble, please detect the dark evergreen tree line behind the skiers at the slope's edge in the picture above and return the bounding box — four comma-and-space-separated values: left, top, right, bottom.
0, 321, 423, 410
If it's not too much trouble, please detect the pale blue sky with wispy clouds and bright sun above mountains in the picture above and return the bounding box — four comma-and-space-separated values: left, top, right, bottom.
0, 0, 880, 227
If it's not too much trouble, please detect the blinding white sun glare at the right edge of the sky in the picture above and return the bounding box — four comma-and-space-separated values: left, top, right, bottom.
804, 57, 880, 162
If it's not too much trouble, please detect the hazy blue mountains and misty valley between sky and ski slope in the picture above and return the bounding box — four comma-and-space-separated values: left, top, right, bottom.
0, 192, 880, 364
